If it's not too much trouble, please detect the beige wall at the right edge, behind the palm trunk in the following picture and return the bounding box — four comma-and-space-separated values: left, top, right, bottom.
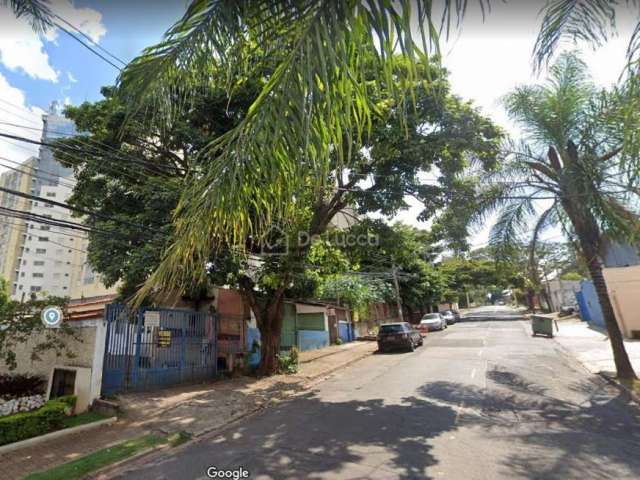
602, 265, 640, 338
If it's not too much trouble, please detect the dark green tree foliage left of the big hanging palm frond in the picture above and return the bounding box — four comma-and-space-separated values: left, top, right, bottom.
56, 80, 260, 300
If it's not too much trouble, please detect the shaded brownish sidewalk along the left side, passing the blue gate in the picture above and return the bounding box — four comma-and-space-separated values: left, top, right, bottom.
0, 342, 377, 480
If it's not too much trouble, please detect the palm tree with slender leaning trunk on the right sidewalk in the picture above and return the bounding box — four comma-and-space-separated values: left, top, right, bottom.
475, 53, 640, 378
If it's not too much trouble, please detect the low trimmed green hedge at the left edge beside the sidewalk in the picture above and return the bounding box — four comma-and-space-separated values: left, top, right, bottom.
0, 396, 76, 445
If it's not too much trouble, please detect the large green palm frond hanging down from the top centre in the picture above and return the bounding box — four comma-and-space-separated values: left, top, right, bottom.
120, 0, 488, 300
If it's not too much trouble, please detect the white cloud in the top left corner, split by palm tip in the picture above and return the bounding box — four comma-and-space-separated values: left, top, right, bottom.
0, 0, 107, 82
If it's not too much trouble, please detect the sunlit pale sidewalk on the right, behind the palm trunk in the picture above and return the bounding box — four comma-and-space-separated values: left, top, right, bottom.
554, 319, 640, 373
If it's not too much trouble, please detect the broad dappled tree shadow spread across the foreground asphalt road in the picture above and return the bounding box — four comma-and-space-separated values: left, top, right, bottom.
127, 369, 640, 479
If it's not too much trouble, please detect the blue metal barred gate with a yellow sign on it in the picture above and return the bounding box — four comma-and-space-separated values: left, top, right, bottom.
102, 304, 217, 395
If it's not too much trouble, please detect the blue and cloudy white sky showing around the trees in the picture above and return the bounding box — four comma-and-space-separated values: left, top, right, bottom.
0, 0, 637, 245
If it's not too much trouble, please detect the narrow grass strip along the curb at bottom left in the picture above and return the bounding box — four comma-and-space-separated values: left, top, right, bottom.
25, 434, 167, 480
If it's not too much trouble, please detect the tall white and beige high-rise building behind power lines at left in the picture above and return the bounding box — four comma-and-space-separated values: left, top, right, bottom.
0, 103, 115, 299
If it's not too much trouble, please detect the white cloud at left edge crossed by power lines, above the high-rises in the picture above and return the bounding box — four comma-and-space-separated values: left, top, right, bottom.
0, 74, 45, 171
